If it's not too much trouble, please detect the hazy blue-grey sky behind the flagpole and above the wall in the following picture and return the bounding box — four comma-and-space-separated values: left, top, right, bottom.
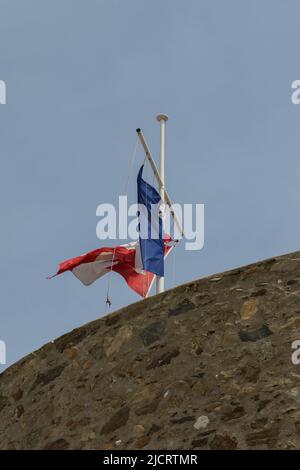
0, 0, 300, 370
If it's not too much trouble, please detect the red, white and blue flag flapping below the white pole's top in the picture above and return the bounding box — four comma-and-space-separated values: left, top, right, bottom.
52, 166, 173, 297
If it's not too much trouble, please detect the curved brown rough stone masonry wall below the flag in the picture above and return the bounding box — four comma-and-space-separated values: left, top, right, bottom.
0, 252, 300, 450
